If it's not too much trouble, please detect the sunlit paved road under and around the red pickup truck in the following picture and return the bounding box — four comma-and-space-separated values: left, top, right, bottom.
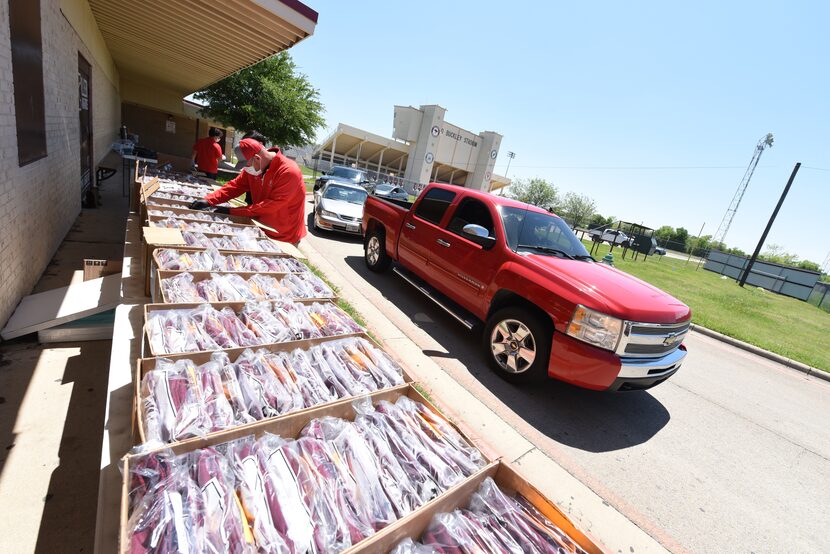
304, 198, 830, 553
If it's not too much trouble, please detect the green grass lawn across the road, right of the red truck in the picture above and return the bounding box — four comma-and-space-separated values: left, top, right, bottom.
585, 241, 830, 371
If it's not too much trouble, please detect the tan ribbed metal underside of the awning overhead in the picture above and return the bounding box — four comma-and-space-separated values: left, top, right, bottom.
89, 0, 317, 96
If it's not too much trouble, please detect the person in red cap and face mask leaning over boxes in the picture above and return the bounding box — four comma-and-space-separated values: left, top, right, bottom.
190, 138, 307, 246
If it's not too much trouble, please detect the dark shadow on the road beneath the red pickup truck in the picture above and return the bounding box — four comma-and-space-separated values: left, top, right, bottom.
345, 252, 671, 452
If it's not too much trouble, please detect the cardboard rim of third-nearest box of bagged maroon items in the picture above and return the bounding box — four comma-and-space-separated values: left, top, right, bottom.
133, 333, 412, 444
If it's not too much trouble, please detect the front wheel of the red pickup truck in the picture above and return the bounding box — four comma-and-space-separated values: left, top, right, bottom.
483, 306, 551, 383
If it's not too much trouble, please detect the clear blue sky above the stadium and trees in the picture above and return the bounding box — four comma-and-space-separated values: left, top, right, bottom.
291, 0, 830, 264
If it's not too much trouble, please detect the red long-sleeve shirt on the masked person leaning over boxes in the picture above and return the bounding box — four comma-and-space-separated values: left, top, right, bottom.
205, 148, 307, 244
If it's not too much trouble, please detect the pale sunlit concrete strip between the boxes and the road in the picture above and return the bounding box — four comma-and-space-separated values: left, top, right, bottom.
300, 234, 668, 553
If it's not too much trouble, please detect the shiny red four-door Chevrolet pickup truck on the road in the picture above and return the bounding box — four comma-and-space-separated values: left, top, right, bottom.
363, 183, 691, 391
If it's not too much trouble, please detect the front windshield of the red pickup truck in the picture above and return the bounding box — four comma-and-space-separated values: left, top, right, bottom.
499, 206, 592, 260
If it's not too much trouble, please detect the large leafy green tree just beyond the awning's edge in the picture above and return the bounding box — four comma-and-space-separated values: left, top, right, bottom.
195, 52, 325, 147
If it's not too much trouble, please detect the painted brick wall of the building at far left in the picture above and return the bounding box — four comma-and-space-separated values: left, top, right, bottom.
0, 0, 120, 327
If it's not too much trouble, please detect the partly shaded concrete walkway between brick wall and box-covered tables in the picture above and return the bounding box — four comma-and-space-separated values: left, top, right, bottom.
0, 152, 129, 552
